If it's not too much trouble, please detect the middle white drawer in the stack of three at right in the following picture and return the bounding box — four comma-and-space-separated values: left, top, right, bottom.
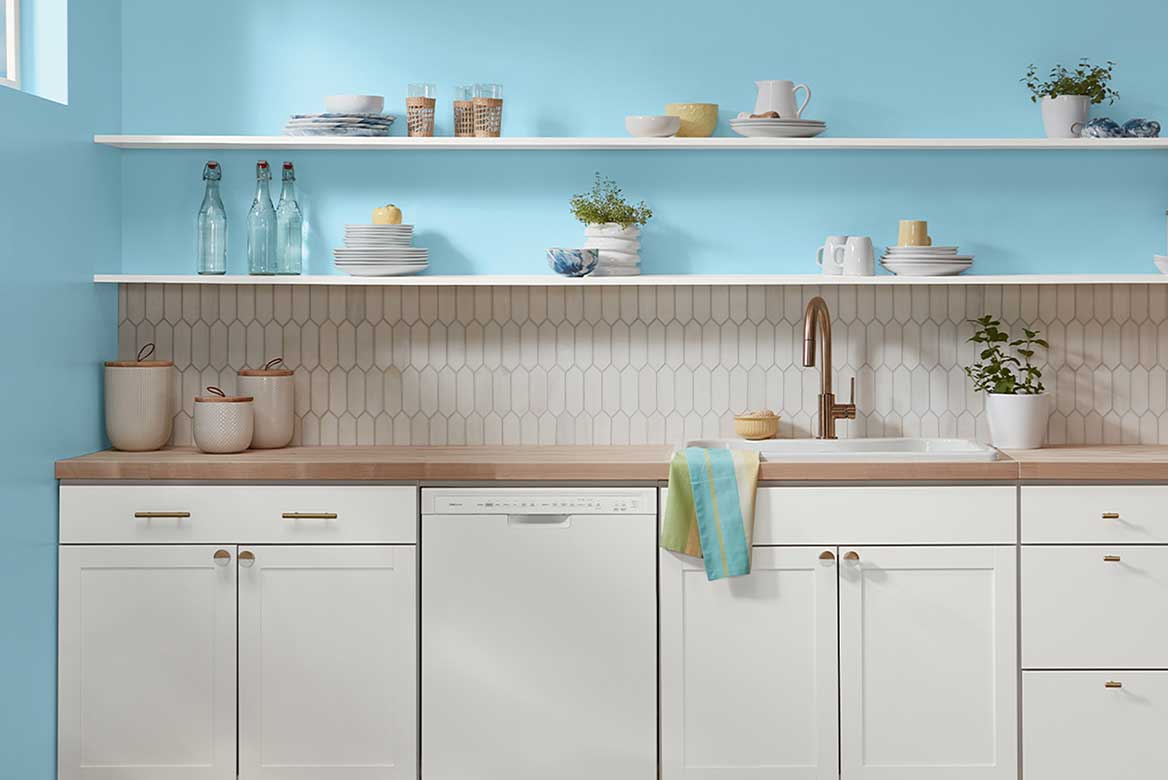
1021, 545, 1168, 669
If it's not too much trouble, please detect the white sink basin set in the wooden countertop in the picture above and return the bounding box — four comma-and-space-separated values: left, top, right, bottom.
686, 439, 997, 461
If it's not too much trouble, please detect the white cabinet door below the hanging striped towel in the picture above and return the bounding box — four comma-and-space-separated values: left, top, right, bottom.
660, 548, 839, 780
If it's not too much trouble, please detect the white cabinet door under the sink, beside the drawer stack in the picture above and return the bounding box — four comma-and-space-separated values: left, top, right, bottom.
840, 546, 1018, 780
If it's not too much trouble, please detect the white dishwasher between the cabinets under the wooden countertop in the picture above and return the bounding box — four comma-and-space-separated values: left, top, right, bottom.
422, 488, 658, 780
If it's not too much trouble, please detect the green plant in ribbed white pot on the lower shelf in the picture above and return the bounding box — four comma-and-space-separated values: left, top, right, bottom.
570, 173, 653, 277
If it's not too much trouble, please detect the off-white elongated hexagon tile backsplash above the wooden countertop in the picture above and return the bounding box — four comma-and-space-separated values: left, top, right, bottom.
118, 285, 1168, 445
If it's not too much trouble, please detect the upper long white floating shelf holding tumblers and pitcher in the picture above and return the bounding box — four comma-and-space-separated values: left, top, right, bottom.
93, 135, 1168, 151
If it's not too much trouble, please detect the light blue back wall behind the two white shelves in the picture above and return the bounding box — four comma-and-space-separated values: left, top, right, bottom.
116, 0, 1168, 273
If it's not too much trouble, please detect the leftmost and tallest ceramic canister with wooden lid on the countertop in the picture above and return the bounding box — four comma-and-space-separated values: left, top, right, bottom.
105, 344, 174, 452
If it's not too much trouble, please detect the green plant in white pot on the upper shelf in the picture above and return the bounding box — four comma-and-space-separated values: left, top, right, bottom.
1022, 58, 1119, 138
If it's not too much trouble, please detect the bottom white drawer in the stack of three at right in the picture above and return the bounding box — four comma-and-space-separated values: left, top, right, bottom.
1022, 671, 1168, 780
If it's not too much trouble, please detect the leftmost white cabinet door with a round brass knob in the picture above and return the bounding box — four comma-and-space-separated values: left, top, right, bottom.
57, 545, 236, 780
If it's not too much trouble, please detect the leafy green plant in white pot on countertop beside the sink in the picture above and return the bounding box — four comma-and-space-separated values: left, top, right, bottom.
965, 314, 1051, 450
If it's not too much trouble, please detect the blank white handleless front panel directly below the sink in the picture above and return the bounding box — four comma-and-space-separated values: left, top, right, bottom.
752, 486, 1017, 544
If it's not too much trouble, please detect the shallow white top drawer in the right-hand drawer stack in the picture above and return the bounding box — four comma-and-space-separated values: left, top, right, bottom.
1022, 485, 1168, 544
